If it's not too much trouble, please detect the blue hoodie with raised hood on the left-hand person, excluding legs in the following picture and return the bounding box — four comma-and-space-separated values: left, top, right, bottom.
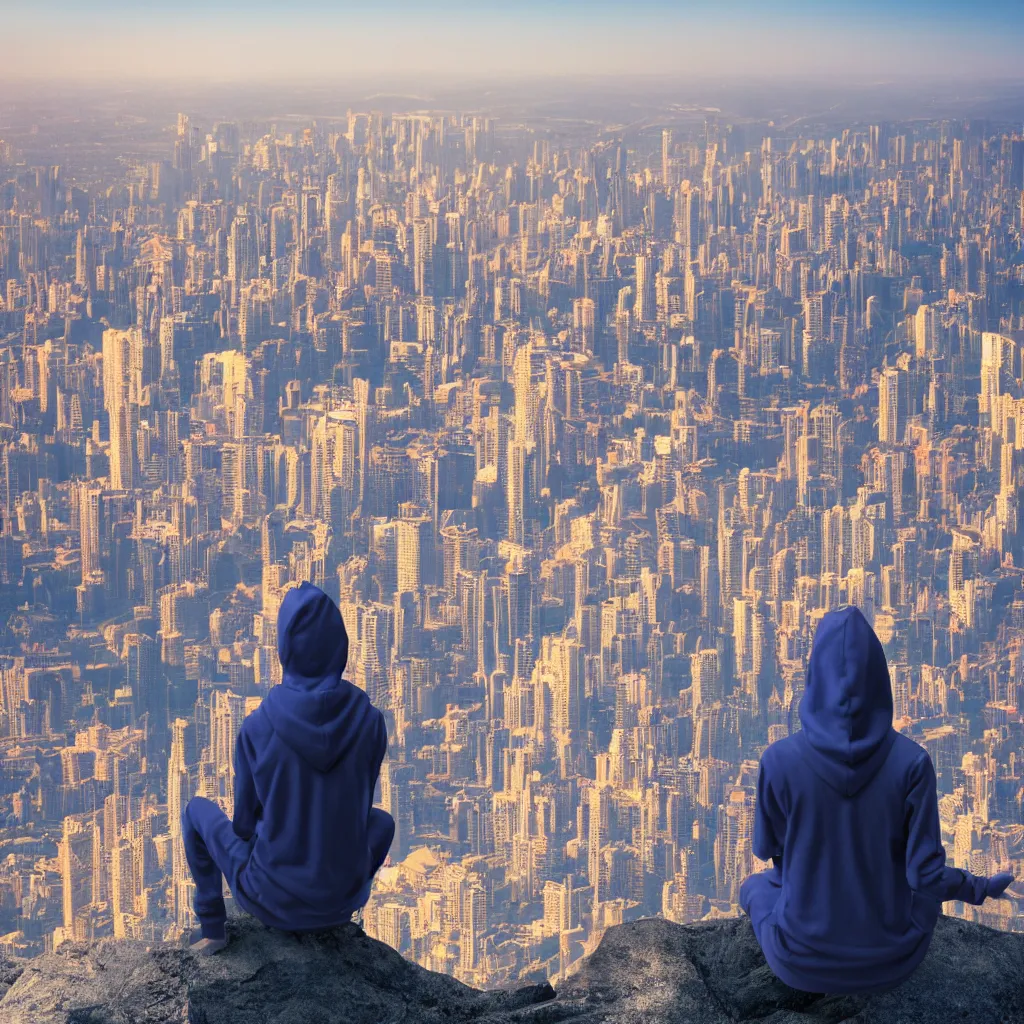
234, 584, 387, 929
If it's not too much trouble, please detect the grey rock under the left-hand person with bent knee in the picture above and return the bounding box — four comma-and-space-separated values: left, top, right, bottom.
0, 918, 554, 1024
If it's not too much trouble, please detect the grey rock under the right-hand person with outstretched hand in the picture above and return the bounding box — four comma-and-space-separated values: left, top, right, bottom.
551, 918, 1024, 1024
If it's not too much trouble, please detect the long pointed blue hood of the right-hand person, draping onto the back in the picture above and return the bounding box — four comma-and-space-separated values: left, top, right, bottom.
798, 607, 896, 797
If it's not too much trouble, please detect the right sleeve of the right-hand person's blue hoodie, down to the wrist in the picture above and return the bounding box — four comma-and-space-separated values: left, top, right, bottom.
906, 752, 988, 906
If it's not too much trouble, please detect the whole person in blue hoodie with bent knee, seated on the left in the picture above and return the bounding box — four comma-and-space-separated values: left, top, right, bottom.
181, 583, 394, 955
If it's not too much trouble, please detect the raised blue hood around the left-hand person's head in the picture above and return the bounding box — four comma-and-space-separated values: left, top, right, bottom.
278, 583, 348, 688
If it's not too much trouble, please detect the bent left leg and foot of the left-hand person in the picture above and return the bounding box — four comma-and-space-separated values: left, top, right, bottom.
181, 797, 249, 952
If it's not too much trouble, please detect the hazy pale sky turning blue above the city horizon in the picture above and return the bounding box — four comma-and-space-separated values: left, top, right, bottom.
0, 0, 1024, 82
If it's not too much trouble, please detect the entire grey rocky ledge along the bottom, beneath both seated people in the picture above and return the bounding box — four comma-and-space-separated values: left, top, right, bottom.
0, 918, 1024, 1024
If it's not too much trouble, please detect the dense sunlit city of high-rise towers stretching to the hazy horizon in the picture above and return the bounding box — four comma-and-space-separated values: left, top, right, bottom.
0, 58, 1024, 988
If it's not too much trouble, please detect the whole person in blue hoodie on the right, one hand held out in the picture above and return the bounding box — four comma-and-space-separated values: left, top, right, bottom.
739, 607, 1013, 994
